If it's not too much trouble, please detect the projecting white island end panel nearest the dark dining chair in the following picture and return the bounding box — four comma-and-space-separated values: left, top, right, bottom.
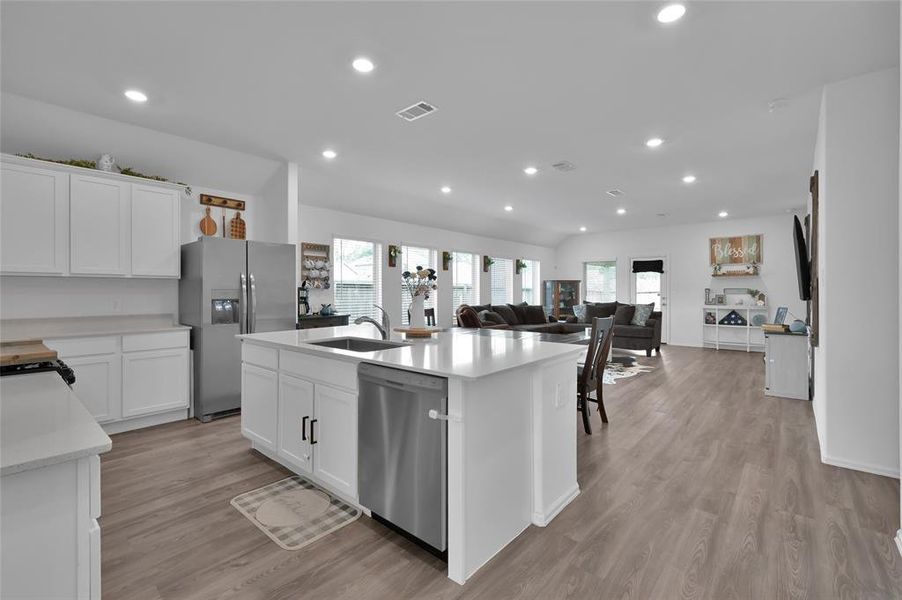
532, 357, 579, 527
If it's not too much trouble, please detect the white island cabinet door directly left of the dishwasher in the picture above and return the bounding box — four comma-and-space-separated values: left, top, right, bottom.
311, 385, 357, 499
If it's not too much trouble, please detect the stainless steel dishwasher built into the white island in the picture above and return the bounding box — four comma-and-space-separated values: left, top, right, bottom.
357, 363, 448, 553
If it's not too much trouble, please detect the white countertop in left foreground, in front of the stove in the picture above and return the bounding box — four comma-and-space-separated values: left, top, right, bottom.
0, 372, 112, 475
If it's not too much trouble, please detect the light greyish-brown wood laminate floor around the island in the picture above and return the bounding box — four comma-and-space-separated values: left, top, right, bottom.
102, 347, 902, 600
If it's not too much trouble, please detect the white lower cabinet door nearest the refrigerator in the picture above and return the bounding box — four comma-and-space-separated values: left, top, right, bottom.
122, 348, 188, 417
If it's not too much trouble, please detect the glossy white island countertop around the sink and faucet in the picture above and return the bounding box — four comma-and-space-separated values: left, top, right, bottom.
238, 323, 585, 379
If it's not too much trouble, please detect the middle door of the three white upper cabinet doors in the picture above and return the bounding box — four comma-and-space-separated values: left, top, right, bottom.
69, 175, 131, 275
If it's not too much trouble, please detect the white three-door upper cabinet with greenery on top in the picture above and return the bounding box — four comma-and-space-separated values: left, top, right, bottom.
0, 154, 181, 278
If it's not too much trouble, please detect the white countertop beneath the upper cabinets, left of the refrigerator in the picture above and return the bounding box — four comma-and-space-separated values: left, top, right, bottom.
0, 315, 191, 341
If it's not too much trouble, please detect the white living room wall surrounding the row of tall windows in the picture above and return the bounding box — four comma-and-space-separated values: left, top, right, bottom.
298, 205, 555, 326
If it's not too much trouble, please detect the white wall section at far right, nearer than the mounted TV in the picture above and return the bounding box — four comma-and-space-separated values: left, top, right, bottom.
815, 69, 899, 476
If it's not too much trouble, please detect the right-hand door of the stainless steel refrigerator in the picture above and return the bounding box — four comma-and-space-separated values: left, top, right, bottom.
247, 242, 297, 333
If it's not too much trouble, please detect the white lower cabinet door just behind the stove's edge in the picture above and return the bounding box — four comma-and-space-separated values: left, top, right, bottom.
60, 354, 122, 423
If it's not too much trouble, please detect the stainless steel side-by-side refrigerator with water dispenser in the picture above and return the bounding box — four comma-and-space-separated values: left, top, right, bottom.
179, 237, 296, 422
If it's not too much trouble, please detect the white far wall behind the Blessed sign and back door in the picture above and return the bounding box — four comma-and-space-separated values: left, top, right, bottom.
556, 214, 805, 346
